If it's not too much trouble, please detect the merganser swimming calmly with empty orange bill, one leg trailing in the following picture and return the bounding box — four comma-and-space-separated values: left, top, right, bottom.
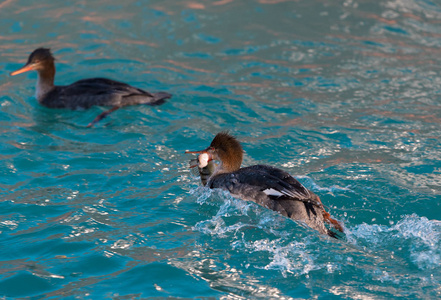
11, 48, 171, 127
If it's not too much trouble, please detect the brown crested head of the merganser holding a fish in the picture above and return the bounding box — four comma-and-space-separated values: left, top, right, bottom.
209, 131, 243, 172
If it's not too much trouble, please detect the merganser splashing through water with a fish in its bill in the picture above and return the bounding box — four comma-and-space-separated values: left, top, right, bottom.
186, 132, 343, 238
